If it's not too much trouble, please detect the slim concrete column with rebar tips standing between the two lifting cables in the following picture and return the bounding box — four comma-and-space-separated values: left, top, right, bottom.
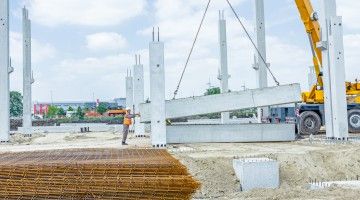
218, 11, 230, 124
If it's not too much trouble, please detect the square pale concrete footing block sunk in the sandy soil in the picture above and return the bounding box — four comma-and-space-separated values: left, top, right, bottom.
233, 158, 280, 191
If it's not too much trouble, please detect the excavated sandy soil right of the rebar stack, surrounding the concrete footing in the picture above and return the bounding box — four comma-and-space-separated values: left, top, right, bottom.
171, 141, 360, 200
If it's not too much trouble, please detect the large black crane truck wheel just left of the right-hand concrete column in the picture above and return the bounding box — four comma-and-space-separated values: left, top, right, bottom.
299, 111, 321, 135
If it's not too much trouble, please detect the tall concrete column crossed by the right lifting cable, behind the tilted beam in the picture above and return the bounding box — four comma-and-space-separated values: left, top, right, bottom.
254, 0, 269, 122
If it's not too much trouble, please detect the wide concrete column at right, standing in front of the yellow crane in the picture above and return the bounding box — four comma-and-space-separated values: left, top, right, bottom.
318, 0, 349, 140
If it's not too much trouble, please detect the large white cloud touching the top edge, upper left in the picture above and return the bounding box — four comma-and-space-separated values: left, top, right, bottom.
29, 0, 146, 26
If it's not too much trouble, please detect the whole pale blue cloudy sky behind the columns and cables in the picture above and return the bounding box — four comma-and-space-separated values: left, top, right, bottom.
6, 0, 360, 101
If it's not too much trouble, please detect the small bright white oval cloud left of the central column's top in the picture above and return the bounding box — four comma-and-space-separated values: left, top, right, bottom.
86, 32, 127, 51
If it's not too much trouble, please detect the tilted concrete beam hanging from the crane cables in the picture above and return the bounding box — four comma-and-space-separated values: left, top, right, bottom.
140, 84, 301, 122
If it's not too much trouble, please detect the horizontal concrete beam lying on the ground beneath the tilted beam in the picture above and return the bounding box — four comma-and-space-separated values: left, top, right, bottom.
166, 124, 295, 144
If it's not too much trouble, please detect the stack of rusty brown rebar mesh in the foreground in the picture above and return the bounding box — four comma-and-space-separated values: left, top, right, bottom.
0, 149, 199, 199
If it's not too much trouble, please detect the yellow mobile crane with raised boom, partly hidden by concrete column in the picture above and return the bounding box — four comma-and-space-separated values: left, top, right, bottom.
295, 0, 360, 134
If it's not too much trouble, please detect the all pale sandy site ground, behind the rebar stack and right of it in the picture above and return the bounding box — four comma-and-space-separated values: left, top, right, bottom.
0, 132, 360, 199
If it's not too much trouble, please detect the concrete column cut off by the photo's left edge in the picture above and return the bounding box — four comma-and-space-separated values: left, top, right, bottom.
0, 0, 10, 142
